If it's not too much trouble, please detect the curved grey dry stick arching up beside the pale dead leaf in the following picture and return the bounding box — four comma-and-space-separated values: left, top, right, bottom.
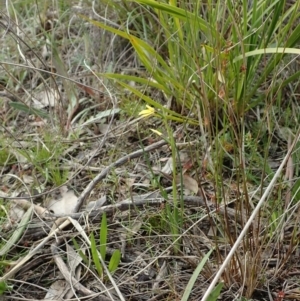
73, 140, 167, 213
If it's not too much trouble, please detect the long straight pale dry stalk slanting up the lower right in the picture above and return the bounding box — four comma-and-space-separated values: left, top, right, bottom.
201, 128, 300, 301
